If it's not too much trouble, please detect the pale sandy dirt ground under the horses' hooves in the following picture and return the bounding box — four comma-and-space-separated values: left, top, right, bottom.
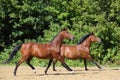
0, 66, 120, 80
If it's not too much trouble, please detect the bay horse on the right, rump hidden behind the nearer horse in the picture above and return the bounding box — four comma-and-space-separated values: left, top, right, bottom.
53, 32, 102, 71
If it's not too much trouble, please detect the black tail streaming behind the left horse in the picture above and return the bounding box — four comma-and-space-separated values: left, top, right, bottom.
3, 44, 22, 64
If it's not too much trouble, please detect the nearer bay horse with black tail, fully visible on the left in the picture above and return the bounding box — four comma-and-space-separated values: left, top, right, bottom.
5, 29, 74, 76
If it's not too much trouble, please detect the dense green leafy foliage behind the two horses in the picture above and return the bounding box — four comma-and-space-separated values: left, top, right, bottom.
0, 0, 120, 66
